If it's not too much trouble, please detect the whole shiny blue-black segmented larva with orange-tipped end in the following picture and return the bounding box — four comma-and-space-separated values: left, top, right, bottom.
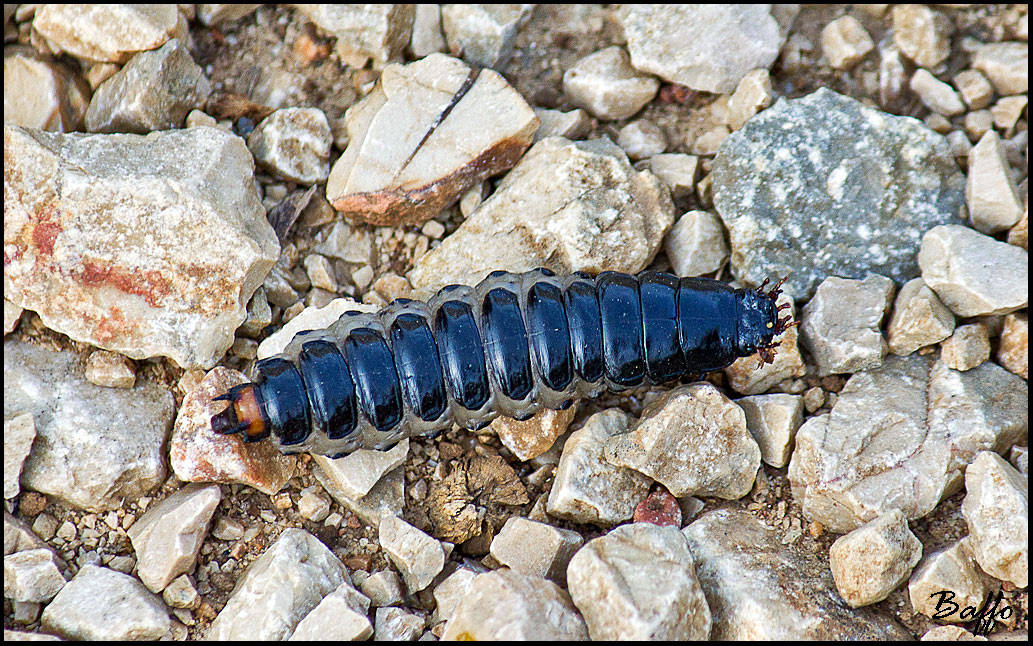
212, 269, 792, 457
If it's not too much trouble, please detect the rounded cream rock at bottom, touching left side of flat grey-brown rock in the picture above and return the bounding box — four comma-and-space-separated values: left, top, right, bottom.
567, 523, 711, 641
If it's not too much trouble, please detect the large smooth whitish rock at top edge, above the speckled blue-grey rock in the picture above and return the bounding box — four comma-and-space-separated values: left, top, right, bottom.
618, 4, 792, 94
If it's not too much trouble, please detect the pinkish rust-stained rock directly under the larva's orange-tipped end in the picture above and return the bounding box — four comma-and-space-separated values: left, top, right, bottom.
168, 366, 298, 495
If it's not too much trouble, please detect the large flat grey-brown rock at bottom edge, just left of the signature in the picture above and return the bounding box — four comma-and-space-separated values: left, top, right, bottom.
682, 510, 910, 641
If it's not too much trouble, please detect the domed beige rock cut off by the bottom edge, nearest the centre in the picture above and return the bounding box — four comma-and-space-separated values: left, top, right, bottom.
441, 570, 589, 641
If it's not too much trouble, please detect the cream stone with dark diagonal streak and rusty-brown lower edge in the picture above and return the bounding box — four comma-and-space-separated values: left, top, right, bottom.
326, 54, 539, 226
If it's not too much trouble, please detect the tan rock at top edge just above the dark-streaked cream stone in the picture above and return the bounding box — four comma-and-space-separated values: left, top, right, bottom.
296, 4, 416, 69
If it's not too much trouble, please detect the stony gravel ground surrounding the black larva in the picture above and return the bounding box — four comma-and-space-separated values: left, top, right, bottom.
4, 5, 1028, 640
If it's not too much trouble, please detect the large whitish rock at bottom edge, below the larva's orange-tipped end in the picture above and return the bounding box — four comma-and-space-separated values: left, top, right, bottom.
207, 528, 348, 640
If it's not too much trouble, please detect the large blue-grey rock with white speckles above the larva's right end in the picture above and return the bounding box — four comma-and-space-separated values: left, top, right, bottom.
712, 88, 965, 299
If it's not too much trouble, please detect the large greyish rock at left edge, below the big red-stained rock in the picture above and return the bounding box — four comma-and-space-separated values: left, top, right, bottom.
3, 341, 175, 511
